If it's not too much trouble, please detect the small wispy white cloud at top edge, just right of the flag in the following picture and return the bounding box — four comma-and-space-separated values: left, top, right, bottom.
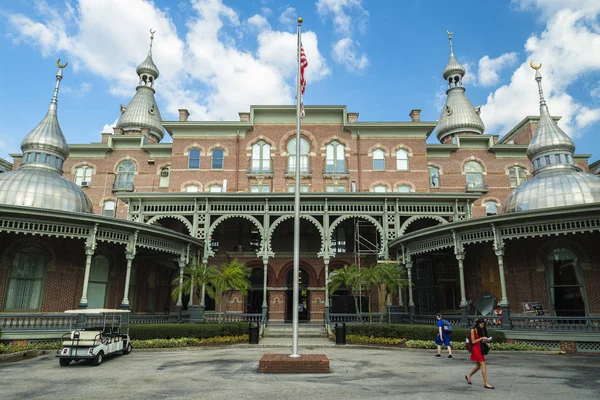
316, 0, 369, 72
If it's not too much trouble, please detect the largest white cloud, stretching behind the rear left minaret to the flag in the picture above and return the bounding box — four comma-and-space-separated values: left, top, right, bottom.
8, 0, 329, 125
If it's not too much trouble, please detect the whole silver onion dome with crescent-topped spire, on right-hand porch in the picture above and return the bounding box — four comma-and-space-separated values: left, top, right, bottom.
503, 63, 600, 213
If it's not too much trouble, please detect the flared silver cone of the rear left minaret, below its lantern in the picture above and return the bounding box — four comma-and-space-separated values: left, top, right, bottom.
115, 86, 165, 141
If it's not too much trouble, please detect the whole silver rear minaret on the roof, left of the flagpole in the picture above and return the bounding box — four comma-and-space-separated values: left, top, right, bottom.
115, 29, 165, 143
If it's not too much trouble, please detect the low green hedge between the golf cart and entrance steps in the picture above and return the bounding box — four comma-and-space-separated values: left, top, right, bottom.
129, 322, 248, 340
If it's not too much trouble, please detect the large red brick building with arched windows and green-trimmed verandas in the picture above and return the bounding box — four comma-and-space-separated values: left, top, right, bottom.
0, 31, 600, 346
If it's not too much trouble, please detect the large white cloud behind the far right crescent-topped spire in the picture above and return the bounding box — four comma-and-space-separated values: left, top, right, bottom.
481, 6, 600, 139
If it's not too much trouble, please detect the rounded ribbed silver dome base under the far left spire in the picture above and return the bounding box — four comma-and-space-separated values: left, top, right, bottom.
0, 167, 94, 213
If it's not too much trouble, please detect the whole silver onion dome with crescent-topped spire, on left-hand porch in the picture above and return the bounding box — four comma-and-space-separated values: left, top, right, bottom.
0, 60, 93, 213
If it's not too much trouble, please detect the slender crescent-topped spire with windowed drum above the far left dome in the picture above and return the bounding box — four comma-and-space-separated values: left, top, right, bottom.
21, 59, 69, 173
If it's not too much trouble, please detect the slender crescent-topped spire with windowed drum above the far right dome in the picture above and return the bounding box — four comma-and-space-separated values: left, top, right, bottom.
527, 61, 575, 174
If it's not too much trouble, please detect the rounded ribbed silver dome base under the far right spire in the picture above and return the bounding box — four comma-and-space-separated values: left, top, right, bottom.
503, 168, 600, 213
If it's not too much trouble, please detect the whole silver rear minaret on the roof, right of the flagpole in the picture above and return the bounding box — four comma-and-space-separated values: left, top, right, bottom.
436, 31, 485, 143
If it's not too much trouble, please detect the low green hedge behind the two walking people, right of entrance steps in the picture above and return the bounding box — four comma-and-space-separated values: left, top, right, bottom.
346, 324, 506, 344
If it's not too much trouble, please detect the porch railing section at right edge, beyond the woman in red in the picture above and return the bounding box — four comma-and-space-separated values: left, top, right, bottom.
510, 315, 600, 332
